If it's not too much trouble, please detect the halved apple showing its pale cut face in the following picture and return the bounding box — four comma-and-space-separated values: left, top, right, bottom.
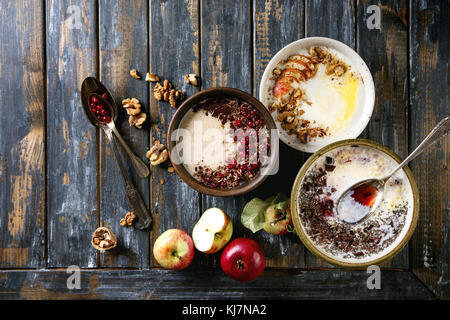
192, 208, 233, 253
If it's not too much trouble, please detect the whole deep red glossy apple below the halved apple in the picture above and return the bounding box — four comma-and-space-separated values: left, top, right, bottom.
220, 238, 266, 281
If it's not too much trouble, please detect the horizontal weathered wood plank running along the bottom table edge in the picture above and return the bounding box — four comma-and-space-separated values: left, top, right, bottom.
0, 269, 434, 300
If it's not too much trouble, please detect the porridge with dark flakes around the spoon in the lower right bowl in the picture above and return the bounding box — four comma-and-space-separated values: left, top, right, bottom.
298, 146, 414, 263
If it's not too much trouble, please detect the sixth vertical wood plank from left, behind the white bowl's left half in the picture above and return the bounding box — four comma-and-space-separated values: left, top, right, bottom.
253, 0, 306, 268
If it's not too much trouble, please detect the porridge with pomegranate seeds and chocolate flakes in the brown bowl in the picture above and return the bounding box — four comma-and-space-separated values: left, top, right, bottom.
177, 97, 270, 189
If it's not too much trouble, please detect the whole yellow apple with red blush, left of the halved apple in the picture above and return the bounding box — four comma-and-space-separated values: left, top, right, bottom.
153, 229, 194, 270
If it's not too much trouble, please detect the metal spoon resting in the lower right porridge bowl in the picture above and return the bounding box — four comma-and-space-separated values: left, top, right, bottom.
336, 117, 450, 224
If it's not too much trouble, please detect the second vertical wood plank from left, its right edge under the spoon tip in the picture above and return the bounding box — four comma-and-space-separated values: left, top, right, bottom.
46, 1, 97, 267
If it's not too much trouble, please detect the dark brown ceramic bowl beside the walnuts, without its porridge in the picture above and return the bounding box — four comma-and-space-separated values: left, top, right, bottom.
167, 87, 278, 197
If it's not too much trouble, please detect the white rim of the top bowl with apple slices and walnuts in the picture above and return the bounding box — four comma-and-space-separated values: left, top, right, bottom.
258, 37, 375, 153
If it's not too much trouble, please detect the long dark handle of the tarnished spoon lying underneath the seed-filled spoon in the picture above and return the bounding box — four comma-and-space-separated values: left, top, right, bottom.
104, 128, 152, 230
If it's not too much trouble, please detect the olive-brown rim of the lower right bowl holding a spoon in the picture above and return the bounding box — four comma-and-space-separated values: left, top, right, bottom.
290, 139, 419, 269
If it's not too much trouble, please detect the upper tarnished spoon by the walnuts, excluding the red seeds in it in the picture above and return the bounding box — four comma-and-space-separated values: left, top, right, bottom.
81, 77, 150, 178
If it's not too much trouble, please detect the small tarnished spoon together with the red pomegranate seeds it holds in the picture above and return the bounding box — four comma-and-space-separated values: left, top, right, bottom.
81, 77, 150, 178
